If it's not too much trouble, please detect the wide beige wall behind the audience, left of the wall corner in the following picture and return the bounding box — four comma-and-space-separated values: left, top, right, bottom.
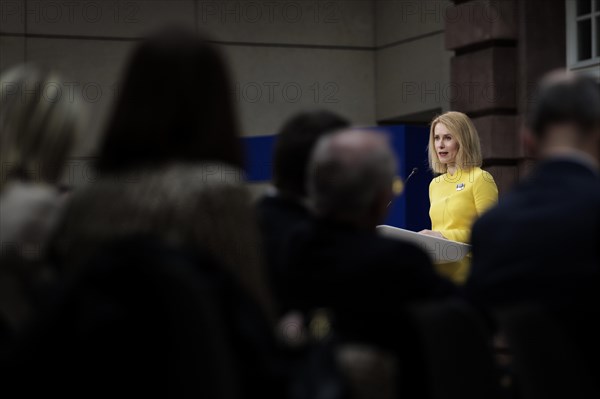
0, 0, 375, 156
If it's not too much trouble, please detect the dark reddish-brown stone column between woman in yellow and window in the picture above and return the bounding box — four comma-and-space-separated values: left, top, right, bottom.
446, 0, 566, 194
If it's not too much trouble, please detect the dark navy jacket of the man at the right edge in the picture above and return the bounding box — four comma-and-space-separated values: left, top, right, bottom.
467, 159, 600, 306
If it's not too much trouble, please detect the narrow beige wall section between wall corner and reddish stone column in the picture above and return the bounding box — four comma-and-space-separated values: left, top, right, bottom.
375, 0, 452, 121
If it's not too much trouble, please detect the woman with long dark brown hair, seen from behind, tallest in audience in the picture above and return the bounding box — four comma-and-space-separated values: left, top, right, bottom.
55, 30, 272, 315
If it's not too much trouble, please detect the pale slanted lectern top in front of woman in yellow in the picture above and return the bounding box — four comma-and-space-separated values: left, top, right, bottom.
377, 225, 471, 263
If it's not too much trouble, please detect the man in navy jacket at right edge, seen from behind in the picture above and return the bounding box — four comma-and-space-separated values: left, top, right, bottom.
466, 73, 600, 308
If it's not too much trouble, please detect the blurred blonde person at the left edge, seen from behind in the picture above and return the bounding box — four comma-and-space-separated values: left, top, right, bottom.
0, 64, 84, 335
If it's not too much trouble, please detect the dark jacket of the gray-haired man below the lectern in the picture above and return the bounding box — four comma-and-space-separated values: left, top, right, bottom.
283, 221, 456, 348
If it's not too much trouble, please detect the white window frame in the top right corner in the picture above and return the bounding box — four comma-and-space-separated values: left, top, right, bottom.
565, 0, 600, 81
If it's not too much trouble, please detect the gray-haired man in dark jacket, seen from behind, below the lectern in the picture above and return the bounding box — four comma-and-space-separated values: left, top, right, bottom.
285, 130, 456, 349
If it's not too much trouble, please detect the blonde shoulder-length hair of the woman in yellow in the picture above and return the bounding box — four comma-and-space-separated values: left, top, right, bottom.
427, 111, 482, 173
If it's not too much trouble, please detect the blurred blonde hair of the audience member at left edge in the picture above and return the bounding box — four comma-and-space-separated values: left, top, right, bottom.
0, 65, 82, 192
